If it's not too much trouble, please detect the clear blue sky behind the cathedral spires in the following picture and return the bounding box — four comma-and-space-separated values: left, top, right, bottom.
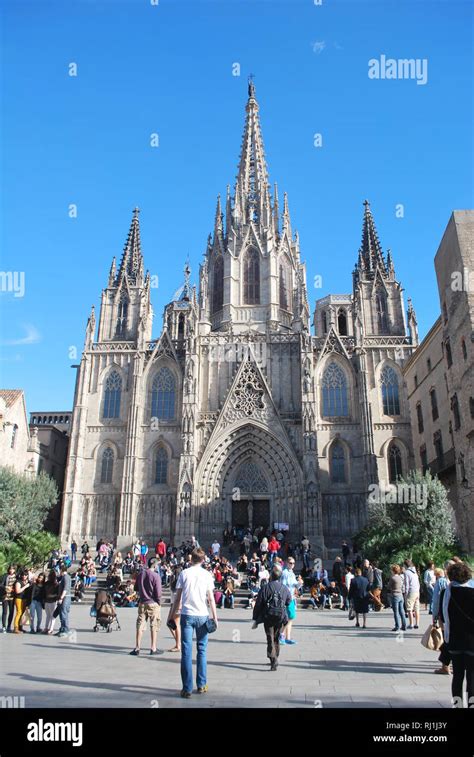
0, 0, 474, 411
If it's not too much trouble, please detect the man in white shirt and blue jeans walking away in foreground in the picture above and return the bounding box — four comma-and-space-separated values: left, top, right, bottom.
168, 548, 217, 699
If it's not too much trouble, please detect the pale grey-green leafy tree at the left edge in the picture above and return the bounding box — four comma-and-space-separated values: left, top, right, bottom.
0, 468, 58, 542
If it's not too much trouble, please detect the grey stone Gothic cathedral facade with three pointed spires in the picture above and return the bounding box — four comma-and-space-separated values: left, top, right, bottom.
61, 83, 418, 554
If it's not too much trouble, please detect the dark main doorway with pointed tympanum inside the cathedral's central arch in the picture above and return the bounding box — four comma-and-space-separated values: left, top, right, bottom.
231, 461, 271, 533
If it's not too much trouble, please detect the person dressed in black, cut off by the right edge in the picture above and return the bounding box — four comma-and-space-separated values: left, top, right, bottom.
443, 562, 474, 708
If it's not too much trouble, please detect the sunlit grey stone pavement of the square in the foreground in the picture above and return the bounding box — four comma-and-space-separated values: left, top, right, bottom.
0, 604, 451, 708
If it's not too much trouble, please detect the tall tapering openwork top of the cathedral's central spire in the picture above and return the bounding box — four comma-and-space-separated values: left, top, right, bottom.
235, 75, 270, 221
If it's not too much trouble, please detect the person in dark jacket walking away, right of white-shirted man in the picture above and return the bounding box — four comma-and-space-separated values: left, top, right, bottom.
253, 563, 291, 670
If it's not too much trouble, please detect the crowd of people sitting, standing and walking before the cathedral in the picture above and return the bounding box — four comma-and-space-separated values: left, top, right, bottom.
0, 529, 474, 701
